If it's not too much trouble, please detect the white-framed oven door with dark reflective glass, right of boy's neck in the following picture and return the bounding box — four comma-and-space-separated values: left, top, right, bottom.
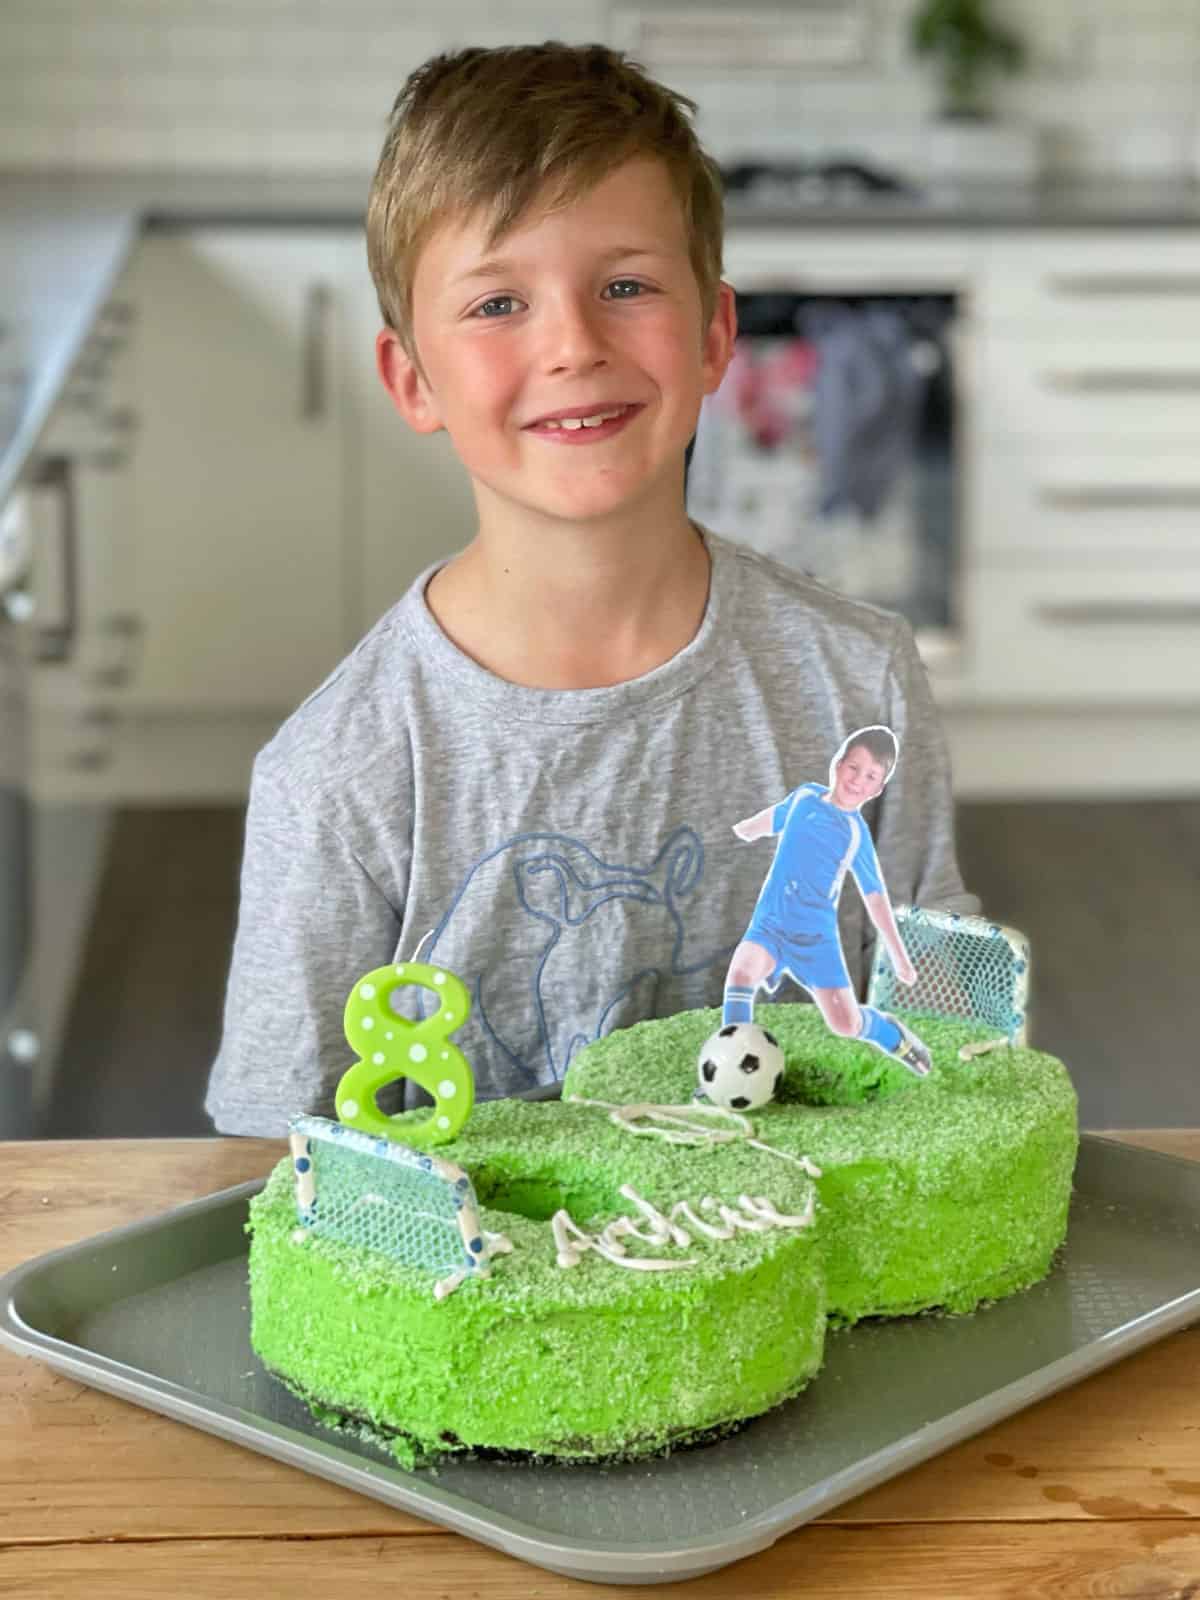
688, 224, 978, 661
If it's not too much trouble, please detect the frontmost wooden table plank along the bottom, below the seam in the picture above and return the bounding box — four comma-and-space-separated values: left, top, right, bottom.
0, 1522, 1200, 1600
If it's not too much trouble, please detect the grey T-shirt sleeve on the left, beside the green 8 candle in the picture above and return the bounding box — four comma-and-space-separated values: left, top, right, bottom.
205, 757, 400, 1138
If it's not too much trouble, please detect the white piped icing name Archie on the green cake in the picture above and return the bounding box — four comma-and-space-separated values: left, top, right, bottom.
550, 1184, 816, 1272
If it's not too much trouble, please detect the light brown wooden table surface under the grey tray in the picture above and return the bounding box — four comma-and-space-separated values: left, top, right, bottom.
0, 1130, 1200, 1600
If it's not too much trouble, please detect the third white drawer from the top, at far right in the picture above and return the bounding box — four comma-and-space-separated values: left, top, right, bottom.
965, 440, 1200, 560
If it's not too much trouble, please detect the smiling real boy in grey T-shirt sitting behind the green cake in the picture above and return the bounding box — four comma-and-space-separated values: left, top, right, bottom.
208, 43, 974, 1134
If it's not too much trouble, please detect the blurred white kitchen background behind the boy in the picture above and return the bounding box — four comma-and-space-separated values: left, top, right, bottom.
0, 0, 1200, 1136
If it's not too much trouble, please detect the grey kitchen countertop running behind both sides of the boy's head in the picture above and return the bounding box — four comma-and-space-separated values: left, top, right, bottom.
0, 170, 1200, 506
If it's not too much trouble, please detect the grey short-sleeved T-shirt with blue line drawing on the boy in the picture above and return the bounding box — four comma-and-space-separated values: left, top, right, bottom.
206, 534, 976, 1136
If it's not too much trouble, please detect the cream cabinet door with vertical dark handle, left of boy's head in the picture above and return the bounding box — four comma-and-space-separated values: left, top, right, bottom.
126, 227, 357, 715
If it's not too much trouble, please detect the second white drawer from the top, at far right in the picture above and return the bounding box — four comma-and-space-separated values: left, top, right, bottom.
965, 333, 1200, 451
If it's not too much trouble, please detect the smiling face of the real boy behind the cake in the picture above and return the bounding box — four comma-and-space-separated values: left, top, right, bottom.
378, 158, 734, 528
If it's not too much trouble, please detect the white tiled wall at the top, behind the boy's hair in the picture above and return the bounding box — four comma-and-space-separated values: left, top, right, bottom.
0, 0, 1200, 176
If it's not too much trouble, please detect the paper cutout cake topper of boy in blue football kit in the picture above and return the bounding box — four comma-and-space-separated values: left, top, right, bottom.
722, 725, 931, 1077
